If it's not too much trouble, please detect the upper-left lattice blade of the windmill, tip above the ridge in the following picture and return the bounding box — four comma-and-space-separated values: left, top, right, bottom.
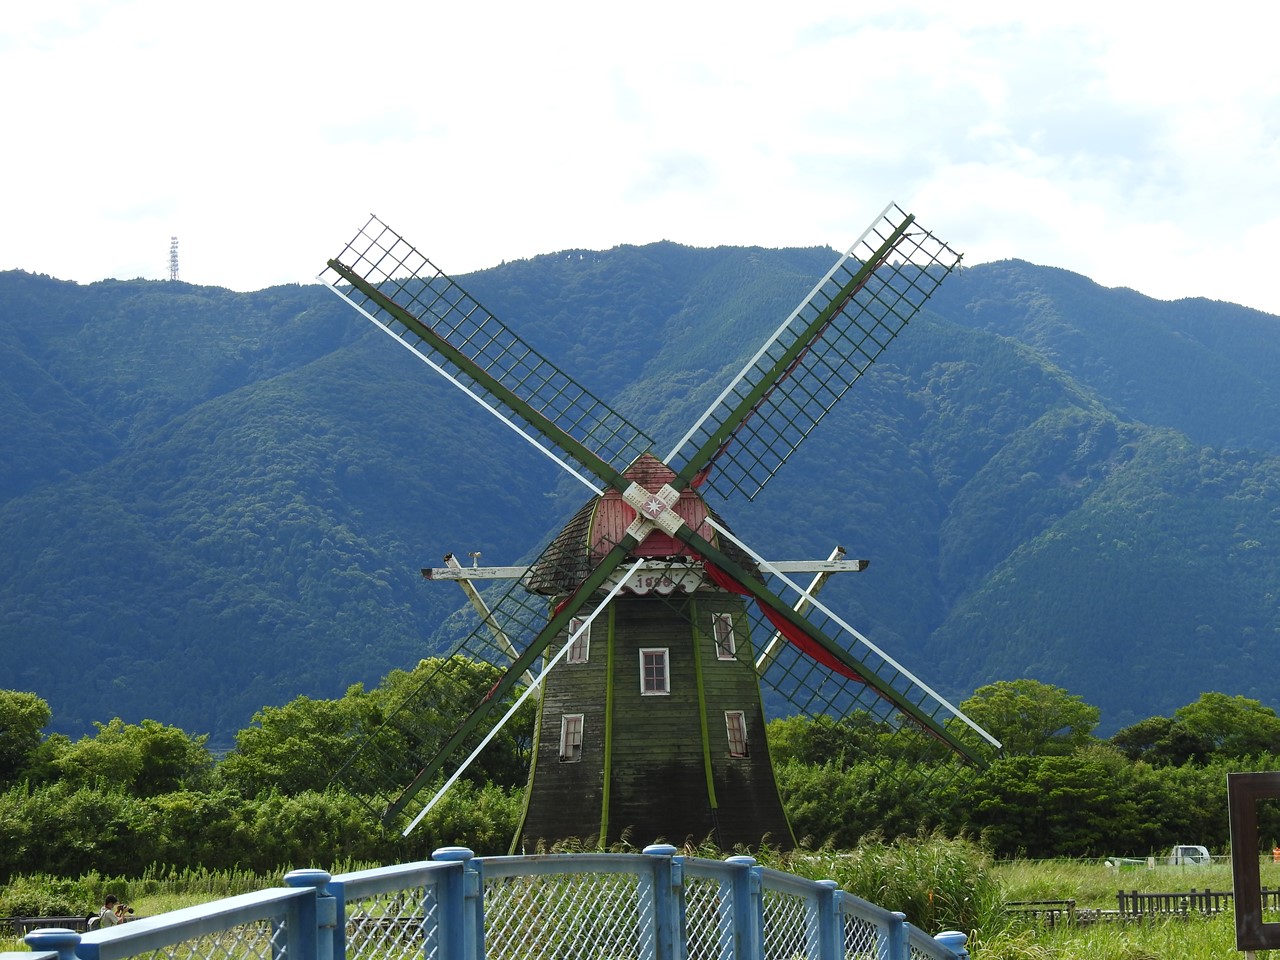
320, 216, 653, 492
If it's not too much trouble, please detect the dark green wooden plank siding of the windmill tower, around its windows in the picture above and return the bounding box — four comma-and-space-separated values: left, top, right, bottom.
520, 590, 794, 850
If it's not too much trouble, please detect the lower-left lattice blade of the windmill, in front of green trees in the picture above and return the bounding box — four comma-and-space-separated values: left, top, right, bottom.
333, 499, 650, 827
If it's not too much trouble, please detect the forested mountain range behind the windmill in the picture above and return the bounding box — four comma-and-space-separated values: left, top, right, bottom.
0, 243, 1280, 745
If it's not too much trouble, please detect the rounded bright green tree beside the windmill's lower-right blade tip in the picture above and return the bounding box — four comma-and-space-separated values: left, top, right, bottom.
960, 680, 1101, 756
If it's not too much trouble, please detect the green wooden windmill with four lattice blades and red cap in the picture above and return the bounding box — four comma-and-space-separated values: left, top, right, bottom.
321, 204, 998, 847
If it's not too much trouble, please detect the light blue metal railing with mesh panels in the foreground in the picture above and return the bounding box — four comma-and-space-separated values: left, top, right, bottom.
0, 845, 969, 960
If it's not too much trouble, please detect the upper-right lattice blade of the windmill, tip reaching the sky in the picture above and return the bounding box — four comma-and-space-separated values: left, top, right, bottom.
666, 204, 960, 499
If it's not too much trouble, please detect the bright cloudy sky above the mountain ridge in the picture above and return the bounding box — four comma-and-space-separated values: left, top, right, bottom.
0, 0, 1280, 314
